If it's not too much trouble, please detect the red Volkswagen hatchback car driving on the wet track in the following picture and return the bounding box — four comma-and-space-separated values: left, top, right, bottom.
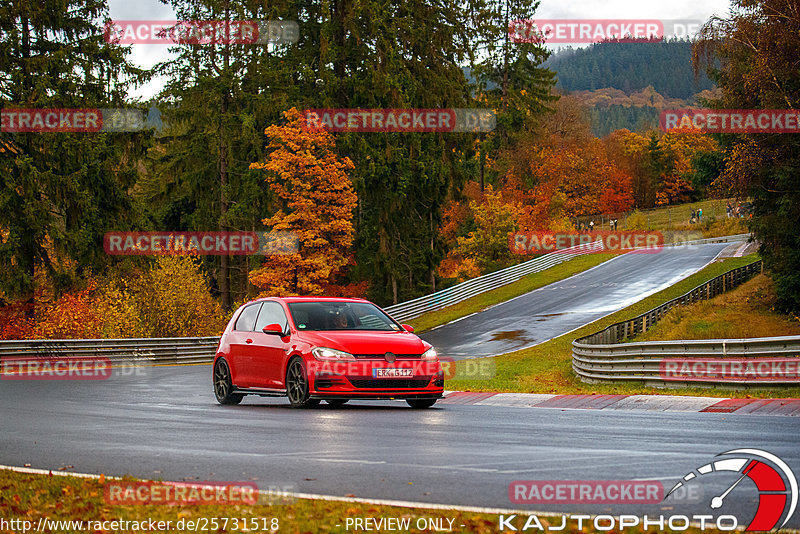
213, 297, 444, 408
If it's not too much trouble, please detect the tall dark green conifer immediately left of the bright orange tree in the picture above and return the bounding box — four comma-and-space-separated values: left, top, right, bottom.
148, 0, 298, 309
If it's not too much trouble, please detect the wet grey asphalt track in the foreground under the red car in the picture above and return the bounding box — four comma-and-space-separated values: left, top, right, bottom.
0, 365, 800, 527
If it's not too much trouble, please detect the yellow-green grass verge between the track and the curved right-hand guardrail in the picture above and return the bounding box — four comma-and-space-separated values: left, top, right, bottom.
446, 254, 800, 398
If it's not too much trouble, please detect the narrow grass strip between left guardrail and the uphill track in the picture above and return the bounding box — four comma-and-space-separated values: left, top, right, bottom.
408, 253, 617, 333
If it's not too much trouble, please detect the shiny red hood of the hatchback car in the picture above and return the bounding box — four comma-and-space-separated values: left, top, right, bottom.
298, 330, 431, 354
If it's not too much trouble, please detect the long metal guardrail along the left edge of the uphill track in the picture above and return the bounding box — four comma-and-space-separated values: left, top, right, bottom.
384, 234, 750, 322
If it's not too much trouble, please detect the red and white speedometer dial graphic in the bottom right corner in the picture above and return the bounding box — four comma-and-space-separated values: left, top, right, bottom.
664, 449, 798, 531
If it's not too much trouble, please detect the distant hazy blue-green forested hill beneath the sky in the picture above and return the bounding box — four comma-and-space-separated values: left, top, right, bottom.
544, 39, 714, 99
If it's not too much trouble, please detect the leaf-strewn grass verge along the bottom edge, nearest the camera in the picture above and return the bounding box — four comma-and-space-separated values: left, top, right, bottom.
0, 469, 740, 534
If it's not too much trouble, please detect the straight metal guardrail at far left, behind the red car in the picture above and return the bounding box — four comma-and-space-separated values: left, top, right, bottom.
0, 336, 219, 365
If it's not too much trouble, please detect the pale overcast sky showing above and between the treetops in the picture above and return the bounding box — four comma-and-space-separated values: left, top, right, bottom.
109, 0, 730, 98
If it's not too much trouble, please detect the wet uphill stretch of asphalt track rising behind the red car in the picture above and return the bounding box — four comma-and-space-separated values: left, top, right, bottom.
420, 243, 730, 359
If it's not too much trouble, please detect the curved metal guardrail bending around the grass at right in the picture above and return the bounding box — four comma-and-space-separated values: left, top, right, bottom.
572, 261, 800, 387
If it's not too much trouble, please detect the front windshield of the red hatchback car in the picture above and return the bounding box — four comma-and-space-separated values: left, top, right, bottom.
289, 302, 401, 332
